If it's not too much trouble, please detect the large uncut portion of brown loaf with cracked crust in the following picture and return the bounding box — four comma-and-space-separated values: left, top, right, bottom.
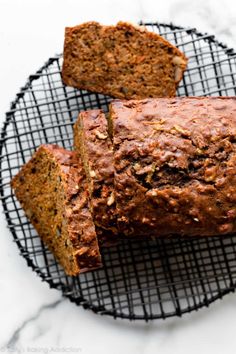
110, 97, 236, 236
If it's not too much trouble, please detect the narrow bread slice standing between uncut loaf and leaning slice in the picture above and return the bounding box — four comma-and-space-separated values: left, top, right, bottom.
74, 110, 117, 241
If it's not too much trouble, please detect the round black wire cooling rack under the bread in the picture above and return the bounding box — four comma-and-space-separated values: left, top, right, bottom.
0, 23, 236, 321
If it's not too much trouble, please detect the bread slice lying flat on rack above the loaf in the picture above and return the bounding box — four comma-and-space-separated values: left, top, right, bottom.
62, 22, 187, 99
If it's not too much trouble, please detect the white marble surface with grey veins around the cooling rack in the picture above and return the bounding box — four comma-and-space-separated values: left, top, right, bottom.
0, 0, 236, 354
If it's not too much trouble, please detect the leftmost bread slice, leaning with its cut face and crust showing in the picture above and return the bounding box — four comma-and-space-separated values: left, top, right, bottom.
11, 145, 101, 275
